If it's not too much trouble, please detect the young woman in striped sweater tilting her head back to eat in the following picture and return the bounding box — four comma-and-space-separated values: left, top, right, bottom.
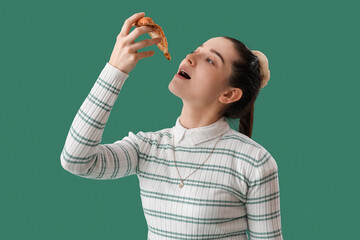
60, 13, 282, 240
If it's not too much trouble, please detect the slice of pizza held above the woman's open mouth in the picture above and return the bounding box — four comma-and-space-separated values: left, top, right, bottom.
131, 17, 171, 60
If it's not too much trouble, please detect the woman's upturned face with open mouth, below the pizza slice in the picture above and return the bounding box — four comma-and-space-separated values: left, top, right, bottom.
168, 37, 237, 107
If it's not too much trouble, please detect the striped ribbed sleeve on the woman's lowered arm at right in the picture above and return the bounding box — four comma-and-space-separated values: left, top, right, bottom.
245, 148, 283, 240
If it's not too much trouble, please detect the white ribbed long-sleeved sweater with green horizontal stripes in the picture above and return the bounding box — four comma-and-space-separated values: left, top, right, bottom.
60, 63, 283, 240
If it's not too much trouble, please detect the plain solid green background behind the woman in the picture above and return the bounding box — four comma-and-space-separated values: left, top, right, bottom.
0, 0, 360, 240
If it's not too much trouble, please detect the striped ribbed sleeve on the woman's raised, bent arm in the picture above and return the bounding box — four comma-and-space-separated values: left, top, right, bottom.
60, 63, 139, 179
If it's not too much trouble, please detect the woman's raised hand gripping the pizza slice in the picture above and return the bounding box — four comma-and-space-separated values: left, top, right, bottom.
109, 12, 161, 74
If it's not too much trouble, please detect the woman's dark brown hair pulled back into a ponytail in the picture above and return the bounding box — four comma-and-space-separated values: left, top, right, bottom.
223, 36, 261, 138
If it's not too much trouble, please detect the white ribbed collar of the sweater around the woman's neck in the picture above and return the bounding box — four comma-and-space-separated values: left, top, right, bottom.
173, 116, 230, 145
